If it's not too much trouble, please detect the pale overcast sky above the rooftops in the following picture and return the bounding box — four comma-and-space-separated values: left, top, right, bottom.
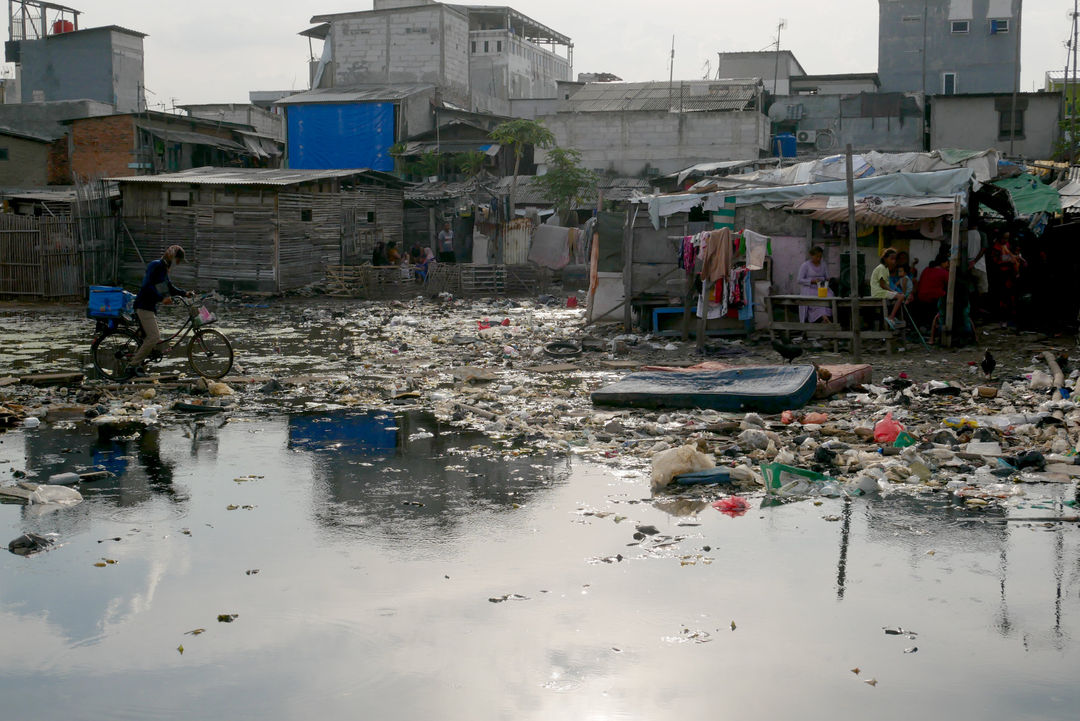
21, 0, 1072, 107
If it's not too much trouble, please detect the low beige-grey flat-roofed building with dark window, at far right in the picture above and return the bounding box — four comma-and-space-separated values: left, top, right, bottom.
930, 93, 1062, 160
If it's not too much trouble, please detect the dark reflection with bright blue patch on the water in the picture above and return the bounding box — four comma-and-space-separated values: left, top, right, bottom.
288, 411, 570, 542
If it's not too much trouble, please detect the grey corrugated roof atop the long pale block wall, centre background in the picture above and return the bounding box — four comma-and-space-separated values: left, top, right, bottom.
559, 80, 760, 112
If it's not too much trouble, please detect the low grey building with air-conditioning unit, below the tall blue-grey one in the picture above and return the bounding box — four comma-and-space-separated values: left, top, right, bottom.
769, 92, 926, 157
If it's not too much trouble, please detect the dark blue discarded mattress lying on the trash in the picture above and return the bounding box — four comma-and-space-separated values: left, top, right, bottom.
592, 365, 818, 413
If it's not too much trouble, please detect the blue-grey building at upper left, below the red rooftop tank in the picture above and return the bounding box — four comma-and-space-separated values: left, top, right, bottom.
6, 25, 146, 112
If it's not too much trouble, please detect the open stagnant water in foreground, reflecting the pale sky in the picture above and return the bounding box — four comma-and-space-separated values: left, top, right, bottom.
0, 412, 1080, 721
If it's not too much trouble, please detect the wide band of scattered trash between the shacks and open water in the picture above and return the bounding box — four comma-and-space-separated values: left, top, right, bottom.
0, 294, 1080, 526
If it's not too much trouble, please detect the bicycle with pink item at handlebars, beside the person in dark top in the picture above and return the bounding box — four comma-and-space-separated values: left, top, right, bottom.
90, 296, 233, 381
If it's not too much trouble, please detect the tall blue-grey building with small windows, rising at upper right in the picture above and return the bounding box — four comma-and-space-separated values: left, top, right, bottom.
878, 0, 1021, 95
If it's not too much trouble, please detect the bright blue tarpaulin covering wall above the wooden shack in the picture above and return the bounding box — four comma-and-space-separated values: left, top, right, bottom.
286, 103, 394, 172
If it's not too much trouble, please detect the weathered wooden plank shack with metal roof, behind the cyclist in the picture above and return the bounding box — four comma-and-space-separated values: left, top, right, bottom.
116, 167, 406, 294
